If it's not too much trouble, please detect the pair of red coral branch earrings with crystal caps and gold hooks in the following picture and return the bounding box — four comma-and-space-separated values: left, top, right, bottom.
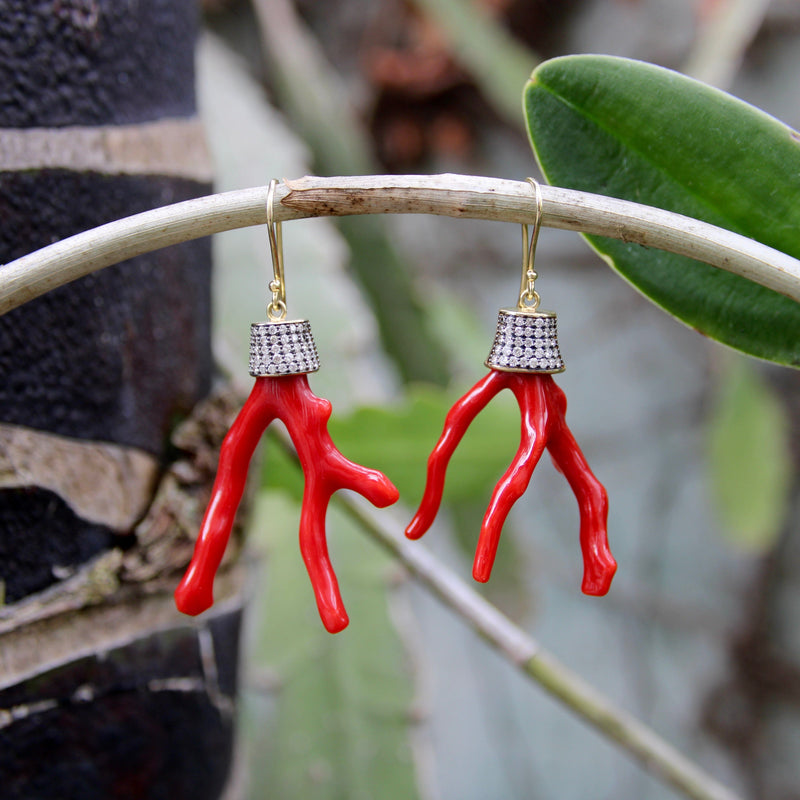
175, 178, 617, 633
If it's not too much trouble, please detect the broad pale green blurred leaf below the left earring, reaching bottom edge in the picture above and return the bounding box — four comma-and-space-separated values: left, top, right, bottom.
242, 491, 419, 800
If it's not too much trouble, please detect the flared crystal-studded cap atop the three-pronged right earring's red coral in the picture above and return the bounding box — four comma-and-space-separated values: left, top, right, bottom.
486, 308, 564, 374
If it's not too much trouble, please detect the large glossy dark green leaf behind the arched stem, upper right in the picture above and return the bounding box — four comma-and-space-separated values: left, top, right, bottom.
524, 56, 800, 367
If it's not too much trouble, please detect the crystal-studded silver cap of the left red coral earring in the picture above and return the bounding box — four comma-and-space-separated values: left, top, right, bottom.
250, 319, 319, 378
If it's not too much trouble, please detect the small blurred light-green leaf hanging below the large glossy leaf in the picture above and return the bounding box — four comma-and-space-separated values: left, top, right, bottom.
709, 359, 792, 552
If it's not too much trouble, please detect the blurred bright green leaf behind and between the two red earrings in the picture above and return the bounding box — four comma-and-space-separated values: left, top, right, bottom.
328, 386, 520, 503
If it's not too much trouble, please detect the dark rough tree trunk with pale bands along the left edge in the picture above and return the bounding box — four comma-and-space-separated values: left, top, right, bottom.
0, 0, 240, 800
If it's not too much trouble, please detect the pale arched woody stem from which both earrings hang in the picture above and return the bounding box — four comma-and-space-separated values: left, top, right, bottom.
0, 175, 800, 314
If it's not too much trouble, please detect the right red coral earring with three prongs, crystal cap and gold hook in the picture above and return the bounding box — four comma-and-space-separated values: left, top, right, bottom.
406, 178, 617, 595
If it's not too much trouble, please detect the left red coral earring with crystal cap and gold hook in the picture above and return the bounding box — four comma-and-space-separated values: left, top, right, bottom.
175, 180, 399, 633
